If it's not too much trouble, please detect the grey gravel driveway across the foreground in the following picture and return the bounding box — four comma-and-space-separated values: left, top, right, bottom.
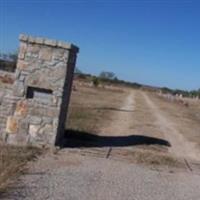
1, 149, 200, 200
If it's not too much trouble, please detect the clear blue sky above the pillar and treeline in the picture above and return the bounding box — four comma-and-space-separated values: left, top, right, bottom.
0, 0, 200, 89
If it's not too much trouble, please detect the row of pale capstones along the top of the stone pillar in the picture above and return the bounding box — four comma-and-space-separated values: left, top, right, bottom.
19, 34, 79, 53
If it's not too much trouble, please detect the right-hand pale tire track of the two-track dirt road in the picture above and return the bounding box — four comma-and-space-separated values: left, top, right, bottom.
141, 92, 200, 161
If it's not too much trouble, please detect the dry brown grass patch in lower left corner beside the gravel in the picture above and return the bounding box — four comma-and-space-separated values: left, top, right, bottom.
0, 143, 41, 192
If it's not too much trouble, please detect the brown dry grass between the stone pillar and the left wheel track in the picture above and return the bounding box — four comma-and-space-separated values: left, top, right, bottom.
66, 86, 126, 133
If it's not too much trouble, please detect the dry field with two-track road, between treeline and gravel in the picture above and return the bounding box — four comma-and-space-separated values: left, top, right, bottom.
66, 80, 200, 167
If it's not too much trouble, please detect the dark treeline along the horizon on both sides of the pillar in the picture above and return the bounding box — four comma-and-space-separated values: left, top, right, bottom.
0, 53, 200, 98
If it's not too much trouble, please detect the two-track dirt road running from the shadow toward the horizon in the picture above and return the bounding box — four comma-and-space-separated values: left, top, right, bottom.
100, 91, 200, 161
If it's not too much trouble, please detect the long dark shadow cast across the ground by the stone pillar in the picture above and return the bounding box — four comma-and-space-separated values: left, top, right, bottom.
62, 130, 171, 148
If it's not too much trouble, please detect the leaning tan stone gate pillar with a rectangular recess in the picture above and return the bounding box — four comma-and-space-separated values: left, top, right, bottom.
5, 35, 79, 145
